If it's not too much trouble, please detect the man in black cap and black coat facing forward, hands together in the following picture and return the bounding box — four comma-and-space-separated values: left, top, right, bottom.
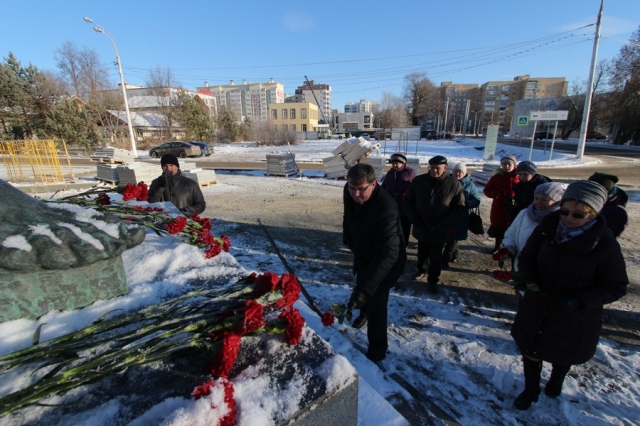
404, 155, 466, 293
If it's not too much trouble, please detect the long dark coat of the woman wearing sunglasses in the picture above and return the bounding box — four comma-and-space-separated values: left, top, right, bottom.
511, 212, 629, 365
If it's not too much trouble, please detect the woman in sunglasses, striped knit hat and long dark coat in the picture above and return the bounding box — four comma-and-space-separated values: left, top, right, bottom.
511, 180, 629, 410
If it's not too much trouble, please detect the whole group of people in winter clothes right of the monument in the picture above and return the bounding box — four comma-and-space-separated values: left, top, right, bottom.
343, 153, 629, 410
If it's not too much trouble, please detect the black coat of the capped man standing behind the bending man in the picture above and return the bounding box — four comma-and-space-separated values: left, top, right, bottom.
404, 173, 466, 244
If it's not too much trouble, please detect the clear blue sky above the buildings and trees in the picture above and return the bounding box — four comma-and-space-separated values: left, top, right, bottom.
0, 0, 640, 110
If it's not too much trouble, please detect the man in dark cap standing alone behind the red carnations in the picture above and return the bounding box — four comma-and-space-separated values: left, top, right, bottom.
147, 154, 207, 217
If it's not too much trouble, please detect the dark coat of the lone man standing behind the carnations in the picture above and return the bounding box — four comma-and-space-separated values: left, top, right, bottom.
147, 170, 207, 214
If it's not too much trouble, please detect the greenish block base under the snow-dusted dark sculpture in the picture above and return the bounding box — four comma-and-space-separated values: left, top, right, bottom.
0, 256, 129, 322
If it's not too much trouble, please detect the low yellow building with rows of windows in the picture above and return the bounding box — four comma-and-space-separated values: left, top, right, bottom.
269, 102, 319, 133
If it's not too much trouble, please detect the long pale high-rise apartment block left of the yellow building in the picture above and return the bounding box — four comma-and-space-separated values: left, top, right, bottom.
198, 79, 284, 122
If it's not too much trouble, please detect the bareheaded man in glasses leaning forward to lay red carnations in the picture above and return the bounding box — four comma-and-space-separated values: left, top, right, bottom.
342, 163, 407, 362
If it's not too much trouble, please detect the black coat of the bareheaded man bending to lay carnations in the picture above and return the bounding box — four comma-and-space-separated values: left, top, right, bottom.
342, 185, 407, 296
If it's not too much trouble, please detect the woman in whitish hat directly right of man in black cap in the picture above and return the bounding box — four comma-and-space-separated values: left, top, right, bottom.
442, 163, 480, 269
